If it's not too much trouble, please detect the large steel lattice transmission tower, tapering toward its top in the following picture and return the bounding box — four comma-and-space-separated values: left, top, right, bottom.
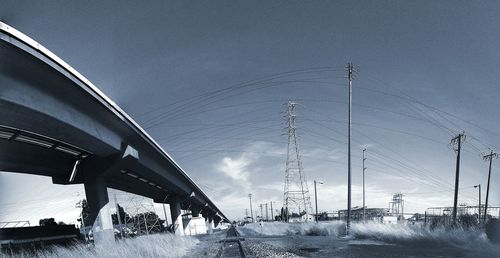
283, 101, 312, 221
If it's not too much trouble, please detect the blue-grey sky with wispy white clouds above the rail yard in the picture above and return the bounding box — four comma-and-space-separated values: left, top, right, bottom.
0, 0, 500, 224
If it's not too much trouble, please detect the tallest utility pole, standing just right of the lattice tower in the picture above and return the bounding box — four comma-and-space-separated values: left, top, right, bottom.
346, 63, 353, 234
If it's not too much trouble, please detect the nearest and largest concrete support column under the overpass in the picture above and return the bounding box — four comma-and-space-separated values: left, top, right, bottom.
84, 177, 115, 244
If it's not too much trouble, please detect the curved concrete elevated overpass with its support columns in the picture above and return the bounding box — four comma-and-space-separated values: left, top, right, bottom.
0, 22, 227, 242
